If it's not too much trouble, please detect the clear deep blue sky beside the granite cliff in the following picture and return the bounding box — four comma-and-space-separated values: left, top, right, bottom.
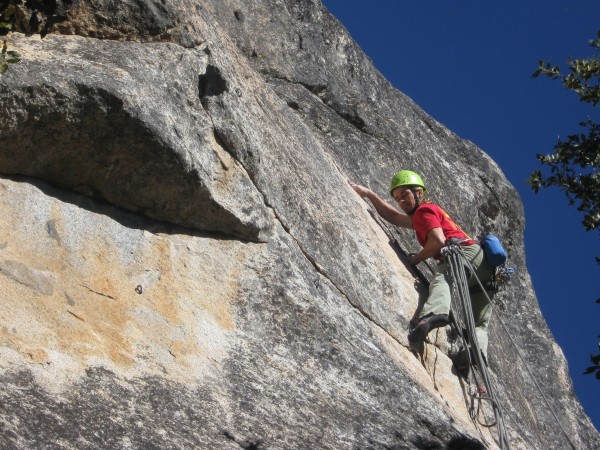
322, 0, 600, 429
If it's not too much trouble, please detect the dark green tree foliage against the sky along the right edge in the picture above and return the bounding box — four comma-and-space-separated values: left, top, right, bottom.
527, 31, 600, 380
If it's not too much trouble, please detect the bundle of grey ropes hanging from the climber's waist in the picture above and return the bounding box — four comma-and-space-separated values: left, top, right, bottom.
442, 244, 510, 450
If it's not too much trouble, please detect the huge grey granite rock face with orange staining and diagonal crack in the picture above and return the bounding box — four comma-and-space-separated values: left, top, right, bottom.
0, 0, 600, 449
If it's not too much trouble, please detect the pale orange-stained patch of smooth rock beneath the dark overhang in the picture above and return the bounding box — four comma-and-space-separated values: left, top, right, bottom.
0, 180, 256, 376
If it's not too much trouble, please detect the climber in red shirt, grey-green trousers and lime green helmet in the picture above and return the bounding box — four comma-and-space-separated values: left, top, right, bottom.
351, 170, 494, 364
